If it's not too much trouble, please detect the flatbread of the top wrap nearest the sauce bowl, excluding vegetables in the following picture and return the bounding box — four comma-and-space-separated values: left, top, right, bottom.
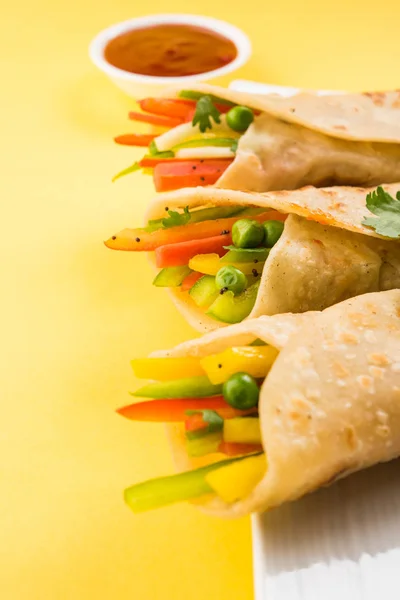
166, 85, 400, 192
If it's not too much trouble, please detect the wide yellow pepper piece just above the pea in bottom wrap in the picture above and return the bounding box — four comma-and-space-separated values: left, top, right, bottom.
200, 346, 278, 384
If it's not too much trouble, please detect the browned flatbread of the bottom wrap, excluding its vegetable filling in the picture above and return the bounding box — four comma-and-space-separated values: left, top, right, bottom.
155, 290, 400, 517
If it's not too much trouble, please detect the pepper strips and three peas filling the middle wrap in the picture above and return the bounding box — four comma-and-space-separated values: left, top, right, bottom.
106, 206, 286, 323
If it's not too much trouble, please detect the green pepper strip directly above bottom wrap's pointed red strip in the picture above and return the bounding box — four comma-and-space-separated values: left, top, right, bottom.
130, 376, 222, 399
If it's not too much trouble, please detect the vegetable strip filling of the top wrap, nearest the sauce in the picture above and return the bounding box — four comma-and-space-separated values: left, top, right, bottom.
113, 90, 258, 192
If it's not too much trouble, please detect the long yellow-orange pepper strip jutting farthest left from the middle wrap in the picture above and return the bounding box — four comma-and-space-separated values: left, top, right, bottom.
104, 210, 287, 252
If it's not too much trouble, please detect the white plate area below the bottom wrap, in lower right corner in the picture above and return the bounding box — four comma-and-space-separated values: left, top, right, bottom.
252, 450, 400, 600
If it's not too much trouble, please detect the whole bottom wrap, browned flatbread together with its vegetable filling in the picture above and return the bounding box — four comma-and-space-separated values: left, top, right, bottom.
118, 291, 400, 516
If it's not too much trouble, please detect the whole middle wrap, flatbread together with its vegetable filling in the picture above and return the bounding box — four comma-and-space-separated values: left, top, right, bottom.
106, 184, 400, 331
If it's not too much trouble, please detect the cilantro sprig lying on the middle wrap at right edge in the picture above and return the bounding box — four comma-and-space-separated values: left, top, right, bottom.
362, 186, 400, 238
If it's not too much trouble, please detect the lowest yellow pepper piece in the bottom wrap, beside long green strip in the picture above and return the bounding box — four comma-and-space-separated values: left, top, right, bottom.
204, 454, 267, 504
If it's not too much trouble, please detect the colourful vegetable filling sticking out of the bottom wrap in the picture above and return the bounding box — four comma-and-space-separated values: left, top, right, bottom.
118, 340, 278, 512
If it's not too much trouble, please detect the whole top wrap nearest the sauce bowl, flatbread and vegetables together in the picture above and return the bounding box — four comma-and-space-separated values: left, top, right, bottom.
114, 85, 400, 192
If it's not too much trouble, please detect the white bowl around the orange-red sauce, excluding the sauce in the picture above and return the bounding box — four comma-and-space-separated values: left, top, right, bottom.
89, 13, 251, 98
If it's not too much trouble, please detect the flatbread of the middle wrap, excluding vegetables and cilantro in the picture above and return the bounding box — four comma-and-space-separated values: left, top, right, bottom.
143, 183, 400, 332
